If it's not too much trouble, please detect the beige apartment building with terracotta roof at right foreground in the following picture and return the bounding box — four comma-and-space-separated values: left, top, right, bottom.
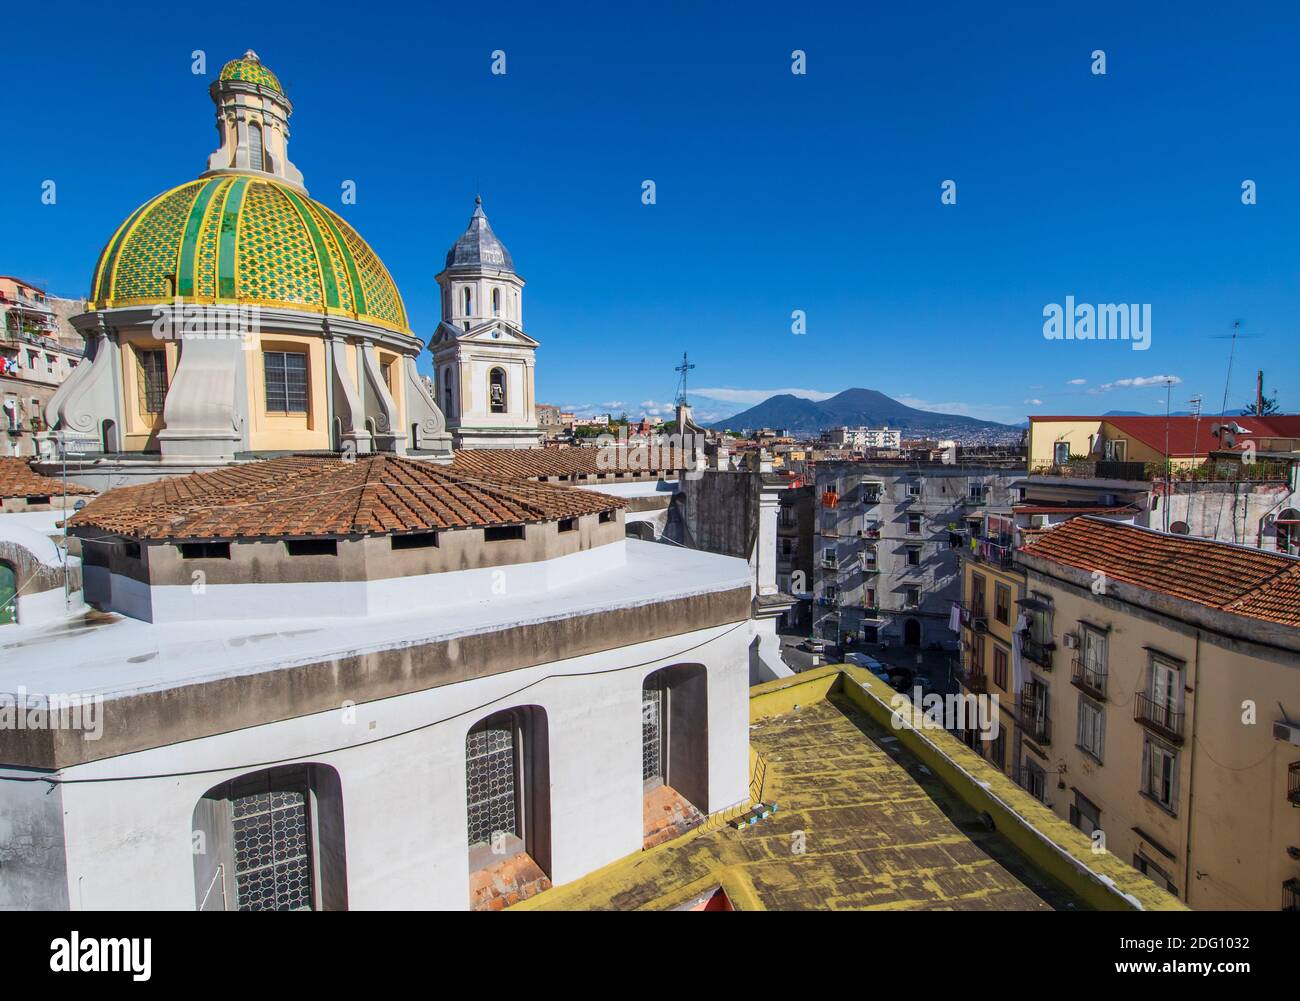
1013, 515, 1300, 910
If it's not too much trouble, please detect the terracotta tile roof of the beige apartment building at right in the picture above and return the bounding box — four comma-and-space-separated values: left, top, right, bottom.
1021, 516, 1300, 628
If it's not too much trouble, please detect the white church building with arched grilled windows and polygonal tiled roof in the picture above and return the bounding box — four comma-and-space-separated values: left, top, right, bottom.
0, 454, 754, 910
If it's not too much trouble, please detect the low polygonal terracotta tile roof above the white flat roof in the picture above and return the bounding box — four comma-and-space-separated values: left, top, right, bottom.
69, 455, 623, 538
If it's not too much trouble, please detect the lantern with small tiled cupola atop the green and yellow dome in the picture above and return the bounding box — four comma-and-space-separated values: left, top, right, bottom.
203, 49, 307, 194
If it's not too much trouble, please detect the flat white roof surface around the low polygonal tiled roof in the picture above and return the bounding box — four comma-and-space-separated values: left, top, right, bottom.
0, 538, 750, 697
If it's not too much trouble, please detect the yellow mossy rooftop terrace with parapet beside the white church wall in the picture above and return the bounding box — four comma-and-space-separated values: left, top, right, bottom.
511, 666, 1186, 910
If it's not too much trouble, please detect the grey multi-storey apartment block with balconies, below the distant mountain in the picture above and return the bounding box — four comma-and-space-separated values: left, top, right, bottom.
813, 460, 1024, 647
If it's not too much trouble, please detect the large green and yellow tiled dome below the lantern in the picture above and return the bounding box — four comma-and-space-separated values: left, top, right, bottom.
90, 171, 410, 333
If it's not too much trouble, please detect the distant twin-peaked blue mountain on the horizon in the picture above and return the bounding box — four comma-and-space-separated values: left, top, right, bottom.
711, 389, 1015, 434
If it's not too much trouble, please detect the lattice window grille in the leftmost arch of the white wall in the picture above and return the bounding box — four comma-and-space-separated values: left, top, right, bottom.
231, 776, 313, 910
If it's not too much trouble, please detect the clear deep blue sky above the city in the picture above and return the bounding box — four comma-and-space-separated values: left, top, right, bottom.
0, 3, 1300, 423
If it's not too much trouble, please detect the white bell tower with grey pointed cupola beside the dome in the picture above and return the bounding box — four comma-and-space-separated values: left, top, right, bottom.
429, 198, 542, 449
